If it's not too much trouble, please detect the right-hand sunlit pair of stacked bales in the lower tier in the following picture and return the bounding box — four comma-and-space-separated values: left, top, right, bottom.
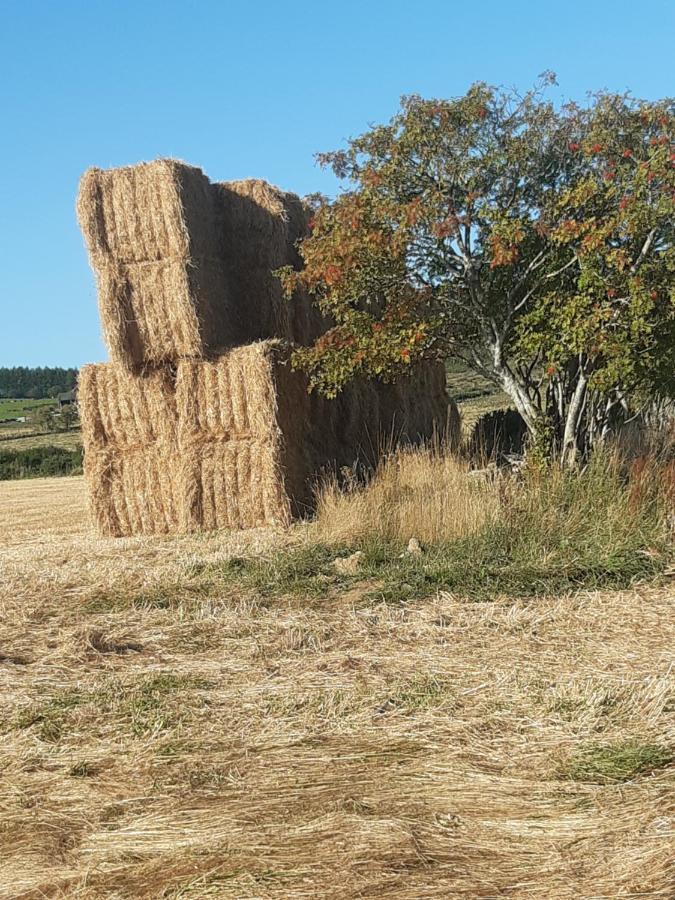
176, 341, 311, 530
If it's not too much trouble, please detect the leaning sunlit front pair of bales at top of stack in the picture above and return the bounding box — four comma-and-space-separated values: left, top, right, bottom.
77, 159, 232, 369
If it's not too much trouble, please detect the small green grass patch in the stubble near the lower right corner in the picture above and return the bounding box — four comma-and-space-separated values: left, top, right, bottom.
561, 741, 675, 784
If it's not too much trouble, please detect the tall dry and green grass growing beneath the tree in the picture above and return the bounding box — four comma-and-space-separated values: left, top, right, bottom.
314, 447, 675, 600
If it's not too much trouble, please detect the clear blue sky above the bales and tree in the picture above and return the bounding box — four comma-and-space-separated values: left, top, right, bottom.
0, 0, 675, 366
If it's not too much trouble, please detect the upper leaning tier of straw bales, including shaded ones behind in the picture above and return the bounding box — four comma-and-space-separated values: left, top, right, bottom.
77, 159, 321, 371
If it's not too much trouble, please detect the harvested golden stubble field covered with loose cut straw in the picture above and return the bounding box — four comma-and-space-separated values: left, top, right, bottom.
0, 478, 675, 900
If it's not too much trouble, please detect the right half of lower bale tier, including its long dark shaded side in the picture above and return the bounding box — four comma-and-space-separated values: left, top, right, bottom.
176, 341, 448, 531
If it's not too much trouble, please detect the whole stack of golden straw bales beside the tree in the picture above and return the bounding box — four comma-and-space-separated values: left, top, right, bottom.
78, 160, 448, 535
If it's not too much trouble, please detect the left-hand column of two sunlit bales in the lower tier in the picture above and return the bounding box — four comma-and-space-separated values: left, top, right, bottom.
78, 363, 178, 536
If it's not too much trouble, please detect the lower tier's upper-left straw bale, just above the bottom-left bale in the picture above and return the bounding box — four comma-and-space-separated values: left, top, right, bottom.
78, 363, 178, 453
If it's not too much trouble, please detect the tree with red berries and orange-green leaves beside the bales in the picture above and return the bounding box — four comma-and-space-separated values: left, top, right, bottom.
280, 75, 675, 463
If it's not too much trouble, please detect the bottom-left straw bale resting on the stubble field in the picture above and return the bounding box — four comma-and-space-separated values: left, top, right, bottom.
84, 444, 179, 537
